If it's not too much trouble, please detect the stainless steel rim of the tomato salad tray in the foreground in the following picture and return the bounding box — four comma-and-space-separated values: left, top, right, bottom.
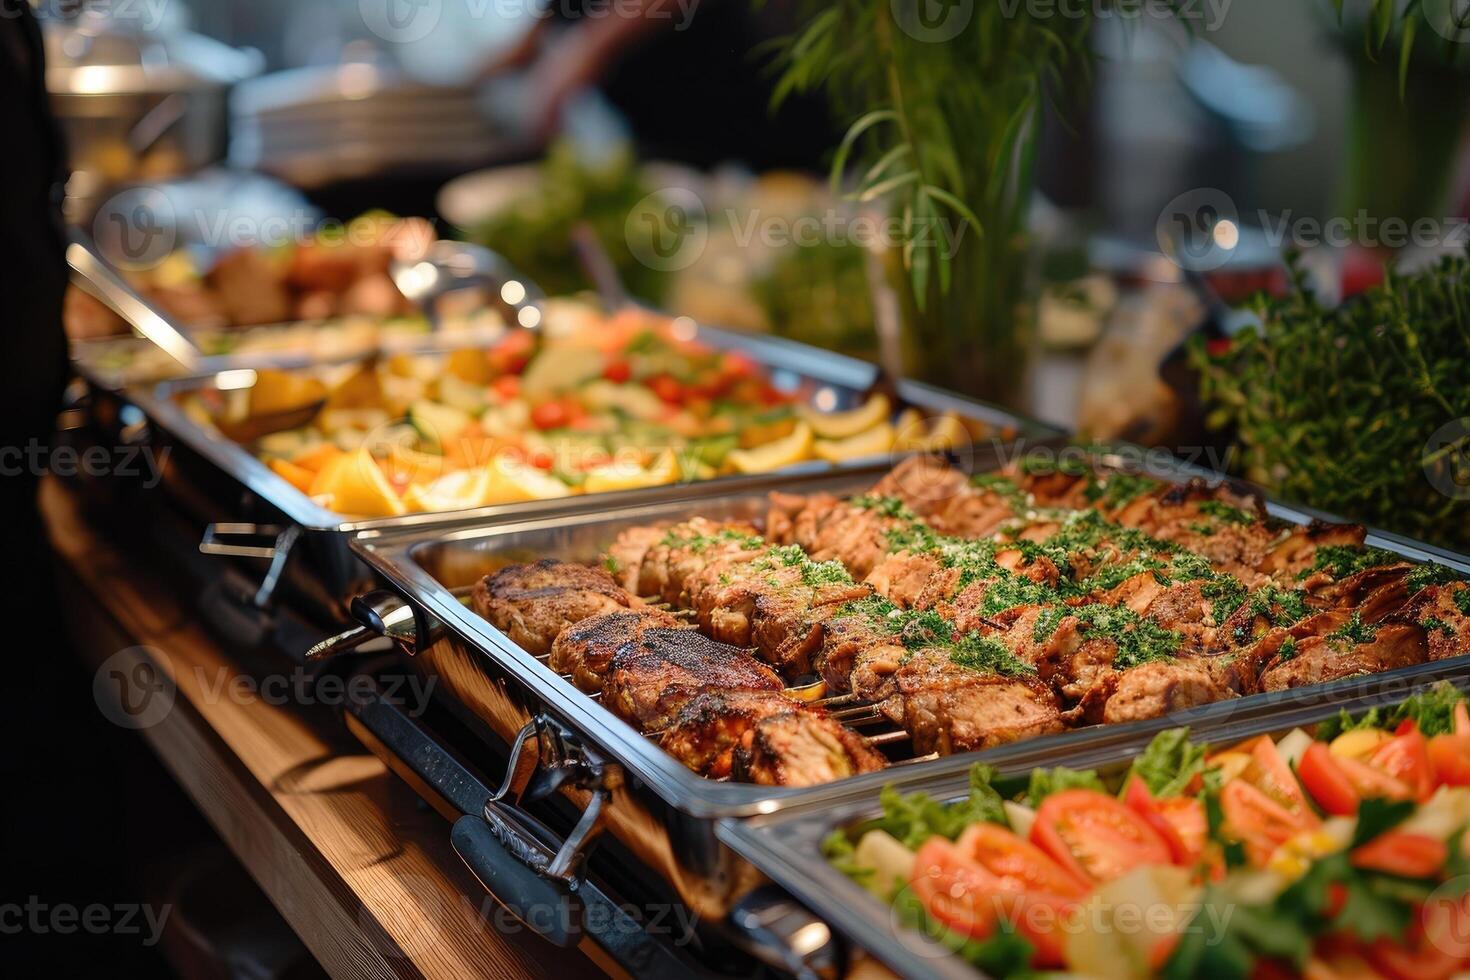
716, 667, 1470, 980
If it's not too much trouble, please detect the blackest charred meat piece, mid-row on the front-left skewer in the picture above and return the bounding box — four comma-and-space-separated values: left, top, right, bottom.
603, 629, 782, 732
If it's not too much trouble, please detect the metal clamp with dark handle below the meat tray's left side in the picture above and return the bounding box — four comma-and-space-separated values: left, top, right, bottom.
450, 714, 622, 946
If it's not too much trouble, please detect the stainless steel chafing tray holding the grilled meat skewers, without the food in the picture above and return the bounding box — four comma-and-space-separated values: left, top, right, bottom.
338, 451, 1470, 934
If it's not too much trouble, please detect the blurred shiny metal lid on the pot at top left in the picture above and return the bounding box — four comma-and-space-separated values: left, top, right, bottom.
43, 4, 265, 96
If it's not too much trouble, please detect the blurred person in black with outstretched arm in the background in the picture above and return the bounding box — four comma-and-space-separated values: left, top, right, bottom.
481, 0, 842, 172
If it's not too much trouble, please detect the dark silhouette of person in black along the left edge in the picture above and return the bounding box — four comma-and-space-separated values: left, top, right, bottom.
0, 0, 178, 976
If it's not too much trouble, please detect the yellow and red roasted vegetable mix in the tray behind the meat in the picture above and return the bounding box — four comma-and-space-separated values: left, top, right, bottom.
182, 304, 982, 517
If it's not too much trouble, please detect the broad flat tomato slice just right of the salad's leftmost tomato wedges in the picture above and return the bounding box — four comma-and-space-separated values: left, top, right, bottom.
1030, 789, 1172, 882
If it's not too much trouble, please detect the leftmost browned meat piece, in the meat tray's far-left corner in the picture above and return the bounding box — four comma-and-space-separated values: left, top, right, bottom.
472, 558, 637, 657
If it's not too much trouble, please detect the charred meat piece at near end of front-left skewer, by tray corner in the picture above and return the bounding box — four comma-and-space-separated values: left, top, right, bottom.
734, 708, 888, 786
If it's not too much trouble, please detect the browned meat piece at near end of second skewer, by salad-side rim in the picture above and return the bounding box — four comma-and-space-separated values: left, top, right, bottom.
883, 649, 1064, 755
